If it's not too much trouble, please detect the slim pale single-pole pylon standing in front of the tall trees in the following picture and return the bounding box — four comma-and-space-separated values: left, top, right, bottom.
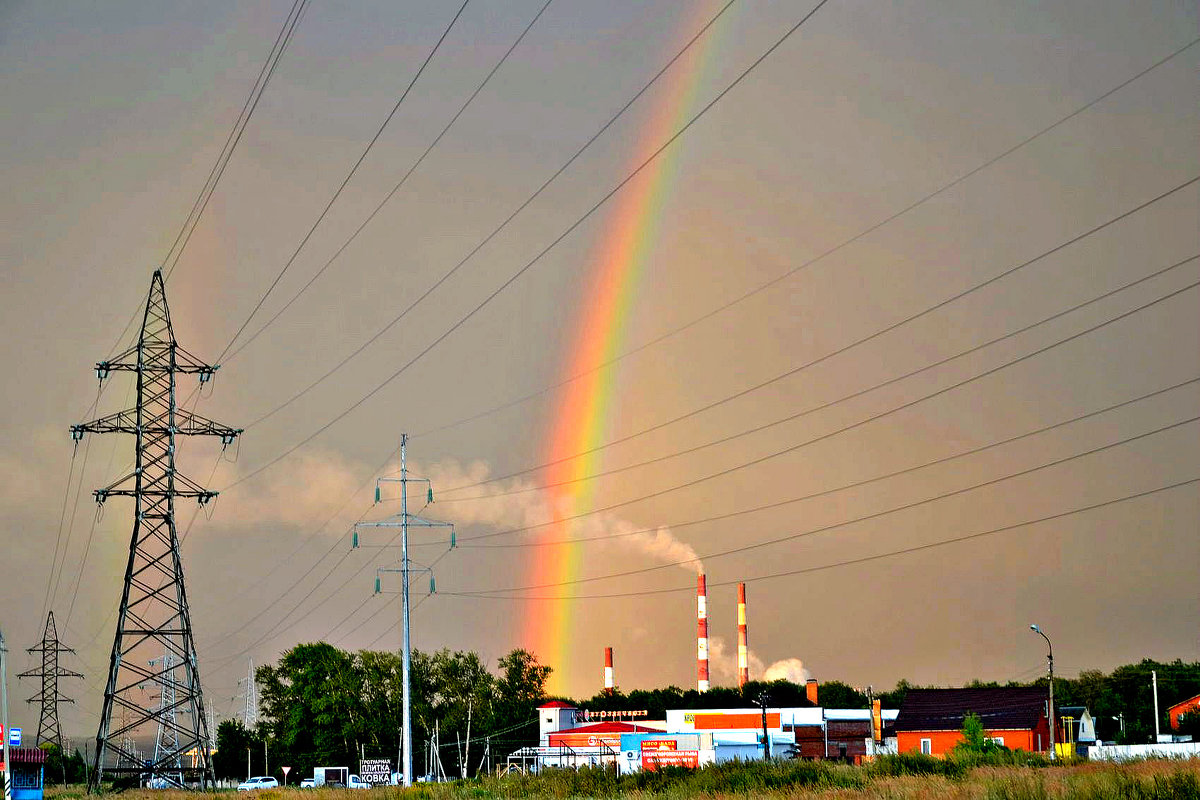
353, 433, 455, 786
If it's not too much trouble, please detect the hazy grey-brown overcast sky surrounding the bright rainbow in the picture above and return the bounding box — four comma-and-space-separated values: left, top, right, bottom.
0, 0, 1200, 735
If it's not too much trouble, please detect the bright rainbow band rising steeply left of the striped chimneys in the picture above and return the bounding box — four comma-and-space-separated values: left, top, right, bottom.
521, 10, 716, 692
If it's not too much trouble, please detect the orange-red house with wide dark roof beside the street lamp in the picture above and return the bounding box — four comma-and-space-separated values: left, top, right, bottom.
895, 687, 1050, 756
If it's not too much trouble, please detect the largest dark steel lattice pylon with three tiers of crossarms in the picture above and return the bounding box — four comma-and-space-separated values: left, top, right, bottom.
71, 270, 241, 789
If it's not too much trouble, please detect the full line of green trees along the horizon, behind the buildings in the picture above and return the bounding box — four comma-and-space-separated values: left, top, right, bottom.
226, 643, 1200, 781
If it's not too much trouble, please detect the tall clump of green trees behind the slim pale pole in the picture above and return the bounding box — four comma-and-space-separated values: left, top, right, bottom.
215, 643, 550, 777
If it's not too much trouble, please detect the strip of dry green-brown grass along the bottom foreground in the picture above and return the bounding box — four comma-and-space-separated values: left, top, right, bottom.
47, 758, 1200, 800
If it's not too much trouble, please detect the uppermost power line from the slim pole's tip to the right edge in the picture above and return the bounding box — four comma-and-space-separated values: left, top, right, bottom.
413, 38, 1200, 438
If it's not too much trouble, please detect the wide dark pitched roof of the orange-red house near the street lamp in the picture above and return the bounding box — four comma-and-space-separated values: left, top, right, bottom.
895, 686, 1046, 730
